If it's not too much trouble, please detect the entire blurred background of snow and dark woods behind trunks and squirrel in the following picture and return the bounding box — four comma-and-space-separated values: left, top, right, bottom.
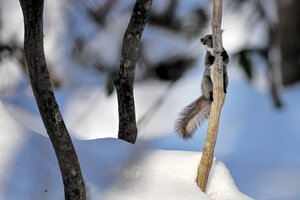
0, 0, 300, 199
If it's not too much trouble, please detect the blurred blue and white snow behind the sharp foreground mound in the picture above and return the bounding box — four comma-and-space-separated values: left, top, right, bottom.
0, 74, 300, 199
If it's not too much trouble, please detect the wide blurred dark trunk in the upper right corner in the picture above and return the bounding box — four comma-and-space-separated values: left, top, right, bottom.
277, 0, 300, 86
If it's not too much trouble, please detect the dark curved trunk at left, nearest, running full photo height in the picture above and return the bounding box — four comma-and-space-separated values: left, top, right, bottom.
20, 0, 86, 200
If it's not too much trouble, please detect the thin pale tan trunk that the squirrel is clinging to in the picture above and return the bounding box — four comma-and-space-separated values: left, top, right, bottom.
197, 0, 226, 192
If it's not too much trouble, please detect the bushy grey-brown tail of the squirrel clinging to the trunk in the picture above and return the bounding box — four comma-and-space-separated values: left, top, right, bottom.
175, 96, 211, 139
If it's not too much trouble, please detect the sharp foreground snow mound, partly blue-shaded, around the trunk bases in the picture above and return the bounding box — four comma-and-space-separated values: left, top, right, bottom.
0, 102, 250, 200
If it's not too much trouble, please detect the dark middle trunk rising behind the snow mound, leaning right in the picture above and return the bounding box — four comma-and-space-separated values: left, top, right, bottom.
115, 0, 152, 144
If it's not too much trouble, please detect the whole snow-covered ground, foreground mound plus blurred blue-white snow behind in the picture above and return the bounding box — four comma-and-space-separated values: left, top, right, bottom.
0, 71, 300, 199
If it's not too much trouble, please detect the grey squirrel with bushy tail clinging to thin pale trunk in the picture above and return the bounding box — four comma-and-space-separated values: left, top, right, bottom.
175, 35, 229, 139
